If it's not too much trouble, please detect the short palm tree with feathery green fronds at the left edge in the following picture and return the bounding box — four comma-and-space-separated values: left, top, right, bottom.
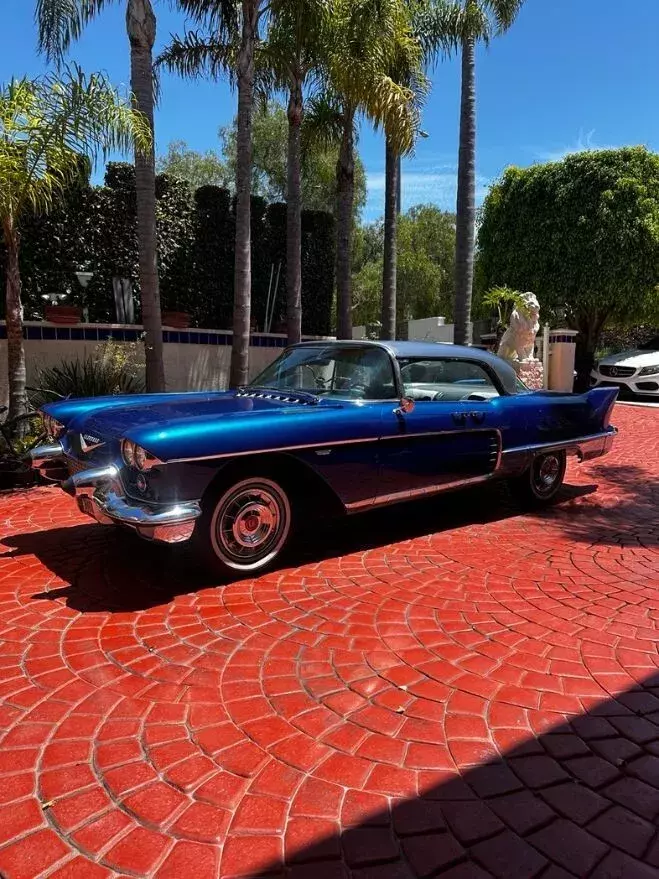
0, 67, 153, 419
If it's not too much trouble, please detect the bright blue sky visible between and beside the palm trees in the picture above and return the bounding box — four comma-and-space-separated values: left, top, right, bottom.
0, 0, 659, 220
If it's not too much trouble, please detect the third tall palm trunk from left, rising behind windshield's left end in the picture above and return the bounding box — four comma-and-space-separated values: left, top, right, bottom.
286, 76, 302, 345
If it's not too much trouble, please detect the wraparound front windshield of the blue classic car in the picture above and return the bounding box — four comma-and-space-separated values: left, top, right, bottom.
250, 344, 396, 400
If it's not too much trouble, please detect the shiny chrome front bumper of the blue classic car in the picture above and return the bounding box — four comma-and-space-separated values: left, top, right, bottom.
30, 443, 201, 543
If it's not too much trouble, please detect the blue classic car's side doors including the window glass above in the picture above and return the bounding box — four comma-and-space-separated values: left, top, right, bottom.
377, 359, 501, 503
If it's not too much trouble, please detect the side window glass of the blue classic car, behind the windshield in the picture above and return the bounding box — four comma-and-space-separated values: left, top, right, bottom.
400, 359, 499, 402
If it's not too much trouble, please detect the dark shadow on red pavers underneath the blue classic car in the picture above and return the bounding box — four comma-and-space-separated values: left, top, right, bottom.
3, 483, 596, 613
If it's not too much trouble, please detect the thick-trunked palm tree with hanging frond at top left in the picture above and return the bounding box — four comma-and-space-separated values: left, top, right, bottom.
36, 0, 175, 391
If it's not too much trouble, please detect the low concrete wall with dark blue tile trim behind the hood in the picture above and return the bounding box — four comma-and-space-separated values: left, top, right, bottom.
0, 321, 328, 403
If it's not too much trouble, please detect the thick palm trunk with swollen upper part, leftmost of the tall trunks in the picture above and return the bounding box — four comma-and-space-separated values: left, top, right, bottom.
126, 0, 165, 393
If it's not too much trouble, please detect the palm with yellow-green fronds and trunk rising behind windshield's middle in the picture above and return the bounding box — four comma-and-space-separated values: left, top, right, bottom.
315, 0, 420, 339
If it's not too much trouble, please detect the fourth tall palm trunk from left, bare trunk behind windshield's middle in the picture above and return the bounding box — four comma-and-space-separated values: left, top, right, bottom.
336, 108, 355, 339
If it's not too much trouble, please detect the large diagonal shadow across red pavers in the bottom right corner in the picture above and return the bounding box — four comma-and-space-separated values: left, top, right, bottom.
232, 676, 659, 879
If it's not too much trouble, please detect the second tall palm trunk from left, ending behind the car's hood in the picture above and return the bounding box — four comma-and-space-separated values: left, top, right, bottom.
229, 0, 260, 388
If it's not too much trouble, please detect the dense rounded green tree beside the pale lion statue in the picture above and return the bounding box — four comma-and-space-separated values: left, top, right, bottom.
478, 147, 659, 379
